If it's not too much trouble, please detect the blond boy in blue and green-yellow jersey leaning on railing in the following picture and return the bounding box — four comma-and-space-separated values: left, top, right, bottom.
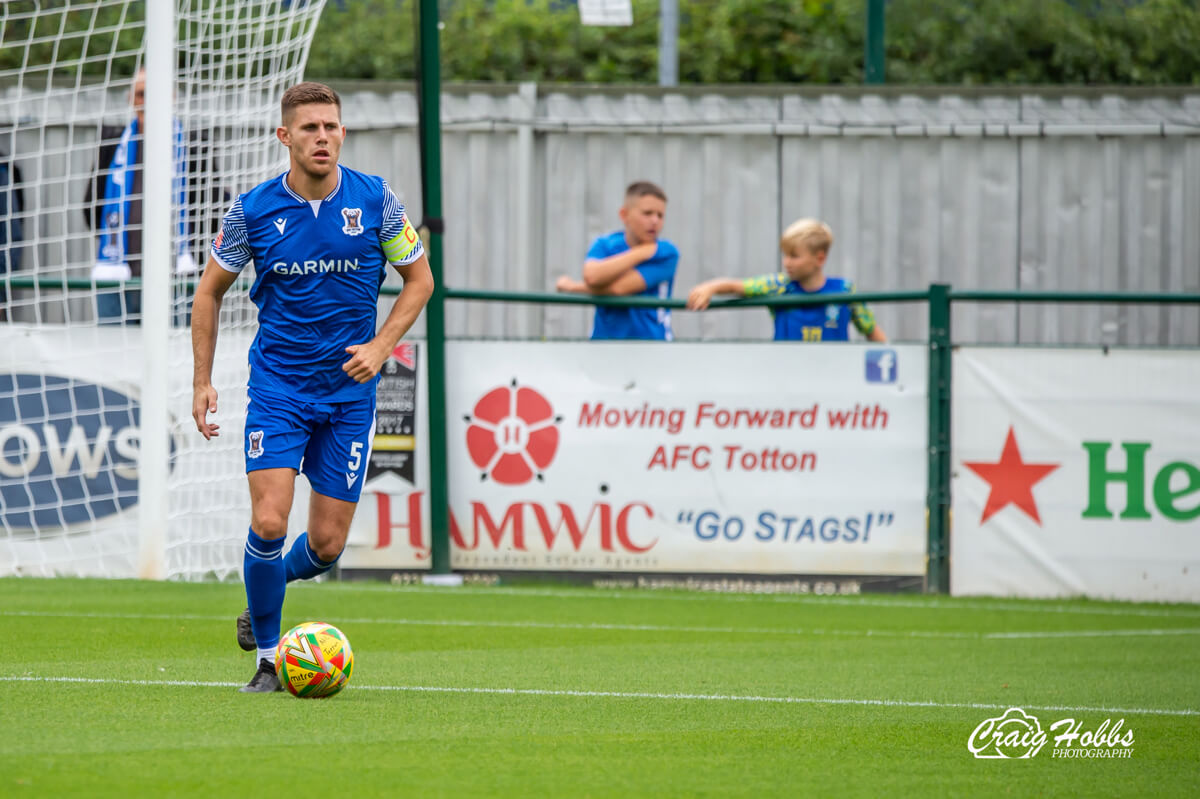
688, 220, 888, 342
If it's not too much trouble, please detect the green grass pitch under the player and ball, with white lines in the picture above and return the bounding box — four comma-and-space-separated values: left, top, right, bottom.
0, 579, 1200, 798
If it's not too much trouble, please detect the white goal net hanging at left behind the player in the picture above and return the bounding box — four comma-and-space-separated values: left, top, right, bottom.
0, 0, 324, 579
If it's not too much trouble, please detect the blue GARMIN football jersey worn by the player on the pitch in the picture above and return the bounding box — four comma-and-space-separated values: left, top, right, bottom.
212, 167, 424, 402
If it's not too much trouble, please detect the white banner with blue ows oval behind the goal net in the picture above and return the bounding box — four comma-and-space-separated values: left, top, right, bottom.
0, 324, 258, 577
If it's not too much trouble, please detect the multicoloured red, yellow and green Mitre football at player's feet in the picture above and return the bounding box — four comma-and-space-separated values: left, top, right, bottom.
275, 621, 354, 699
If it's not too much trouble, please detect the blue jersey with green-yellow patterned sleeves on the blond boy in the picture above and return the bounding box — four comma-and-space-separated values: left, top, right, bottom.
742, 272, 875, 341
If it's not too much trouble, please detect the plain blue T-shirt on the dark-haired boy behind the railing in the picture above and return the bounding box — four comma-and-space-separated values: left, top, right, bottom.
588, 230, 679, 341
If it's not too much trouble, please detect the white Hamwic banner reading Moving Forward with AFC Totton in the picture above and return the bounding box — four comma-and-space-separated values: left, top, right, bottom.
343, 342, 928, 577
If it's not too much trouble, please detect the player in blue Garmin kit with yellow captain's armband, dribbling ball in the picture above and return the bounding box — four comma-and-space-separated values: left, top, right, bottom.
192, 83, 433, 693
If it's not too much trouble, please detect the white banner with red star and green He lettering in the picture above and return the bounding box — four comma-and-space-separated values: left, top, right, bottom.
950, 348, 1200, 602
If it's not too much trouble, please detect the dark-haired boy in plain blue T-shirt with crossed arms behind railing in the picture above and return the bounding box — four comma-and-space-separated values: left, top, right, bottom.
554, 181, 679, 341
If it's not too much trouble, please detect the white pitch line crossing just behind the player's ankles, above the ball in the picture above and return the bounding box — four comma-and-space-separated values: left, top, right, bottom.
0, 611, 1200, 641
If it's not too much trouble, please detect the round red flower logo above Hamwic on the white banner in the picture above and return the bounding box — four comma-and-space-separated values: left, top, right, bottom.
464, 380, 563, 486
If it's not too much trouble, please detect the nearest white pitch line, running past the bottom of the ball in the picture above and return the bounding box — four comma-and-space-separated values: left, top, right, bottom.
0, 675, 1200, 716
